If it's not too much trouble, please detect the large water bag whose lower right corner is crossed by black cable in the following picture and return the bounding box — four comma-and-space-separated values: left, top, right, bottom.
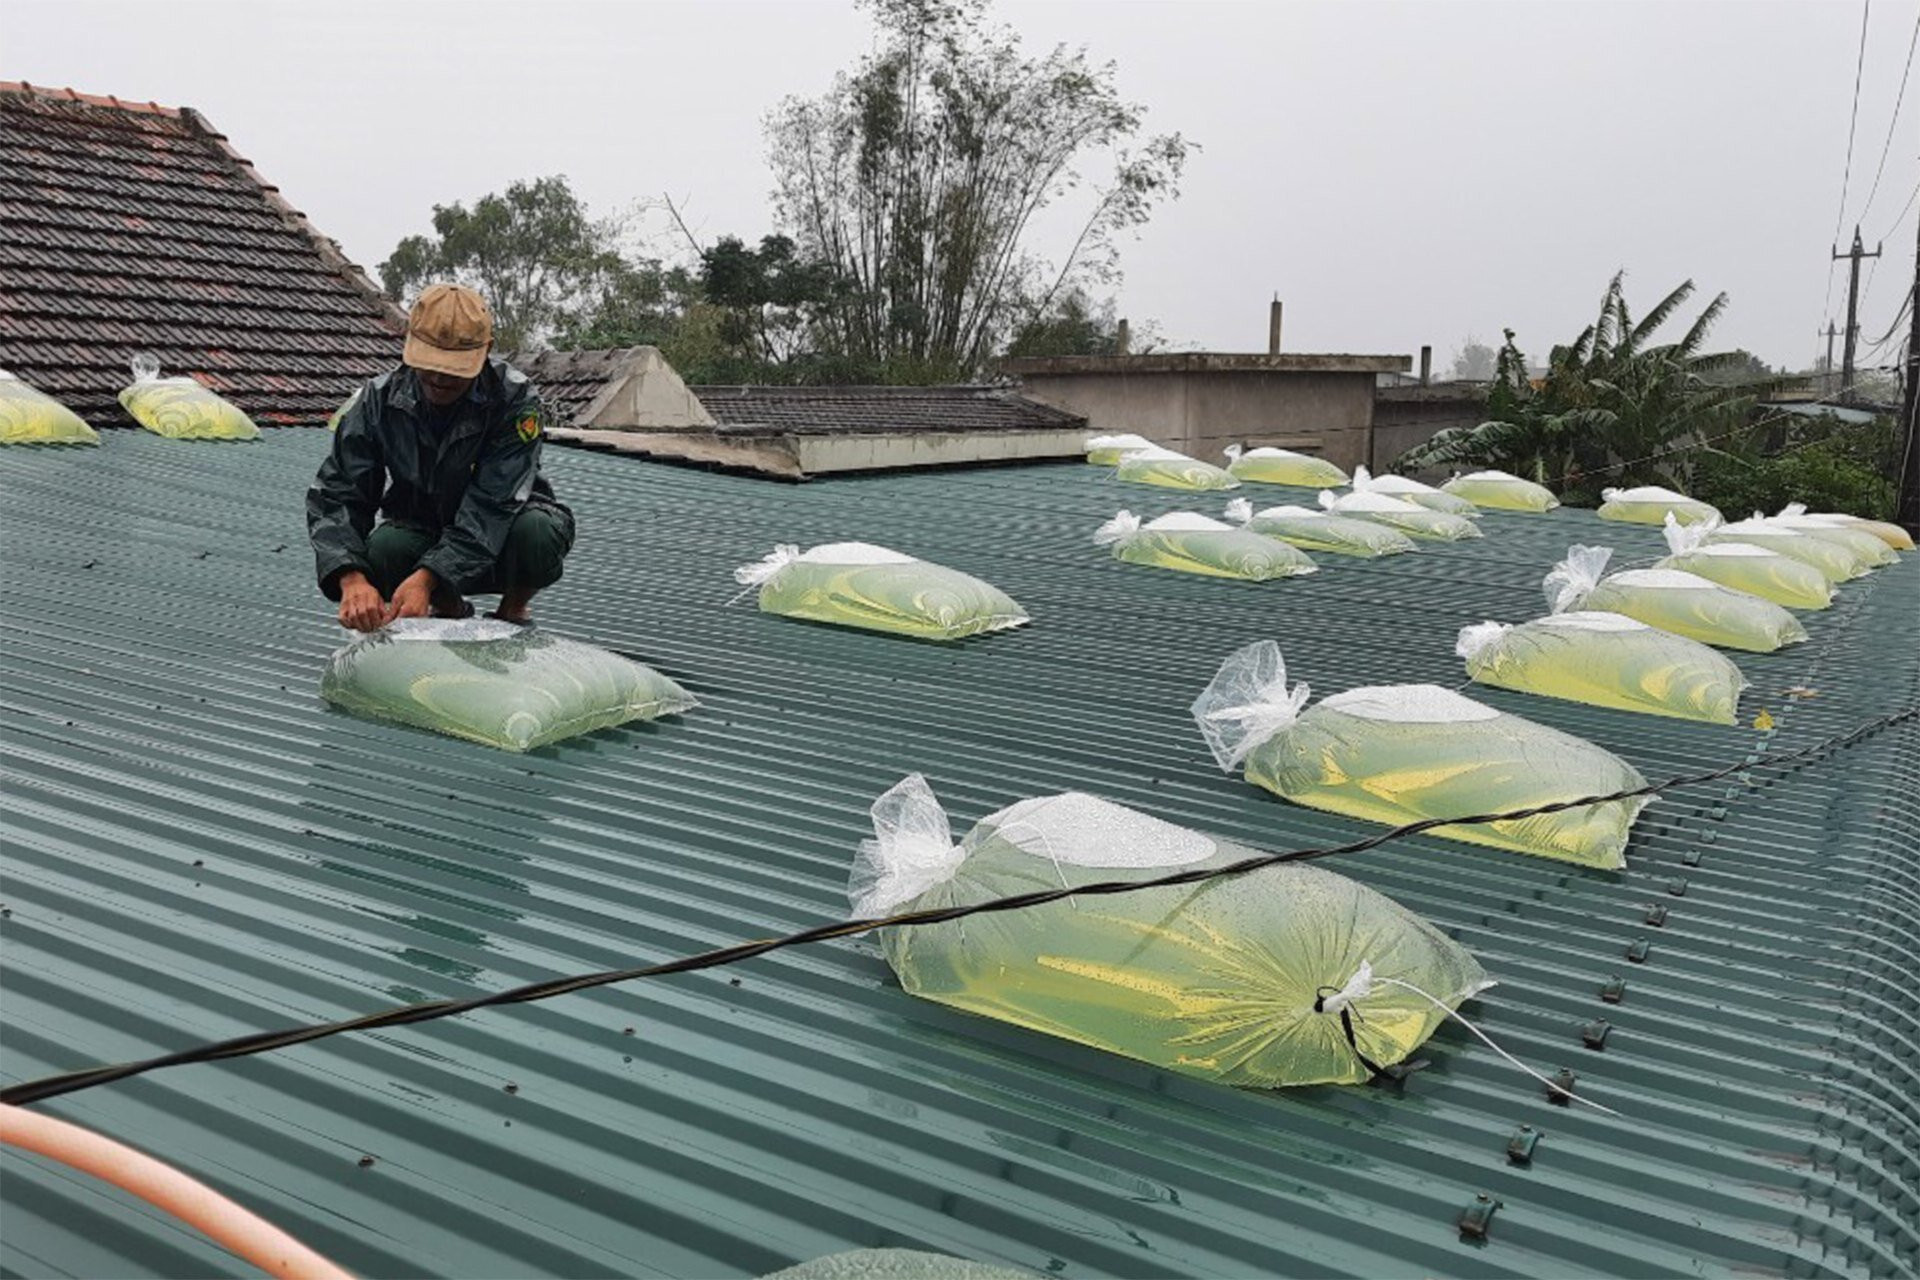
1192, 641, 1645, 867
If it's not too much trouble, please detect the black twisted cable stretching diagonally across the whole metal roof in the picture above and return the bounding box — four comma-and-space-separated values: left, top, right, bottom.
0, 706, 1920, 1105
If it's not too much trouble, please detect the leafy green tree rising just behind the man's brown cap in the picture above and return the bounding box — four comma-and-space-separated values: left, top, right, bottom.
380, 177, 637, 349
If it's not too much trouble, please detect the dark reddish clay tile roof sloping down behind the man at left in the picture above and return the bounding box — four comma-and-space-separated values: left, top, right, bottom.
0, 81, 403, 426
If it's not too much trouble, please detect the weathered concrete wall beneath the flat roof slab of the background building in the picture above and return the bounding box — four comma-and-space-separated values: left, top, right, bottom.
1021, 370, 1375, 468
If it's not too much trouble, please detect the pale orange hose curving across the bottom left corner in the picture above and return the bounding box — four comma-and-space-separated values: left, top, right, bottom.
0, 1103, 353, 1280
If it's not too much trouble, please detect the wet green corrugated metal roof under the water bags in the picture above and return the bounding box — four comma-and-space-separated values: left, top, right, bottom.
0, 434, 1920, 1276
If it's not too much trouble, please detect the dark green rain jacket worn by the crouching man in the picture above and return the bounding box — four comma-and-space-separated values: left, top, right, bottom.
307, 355, 572, 601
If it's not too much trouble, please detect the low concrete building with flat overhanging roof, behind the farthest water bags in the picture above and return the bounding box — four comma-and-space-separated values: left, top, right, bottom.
1004, 351, 1413, 468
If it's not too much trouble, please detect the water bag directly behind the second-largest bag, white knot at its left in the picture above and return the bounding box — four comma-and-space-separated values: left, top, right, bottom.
1453, 612, 1747, 723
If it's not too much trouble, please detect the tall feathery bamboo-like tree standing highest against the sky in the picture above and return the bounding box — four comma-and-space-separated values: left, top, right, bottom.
768, 0, 1188, 376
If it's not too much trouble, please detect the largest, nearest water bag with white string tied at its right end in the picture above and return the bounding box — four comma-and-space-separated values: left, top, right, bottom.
849, 773, 1492, 1088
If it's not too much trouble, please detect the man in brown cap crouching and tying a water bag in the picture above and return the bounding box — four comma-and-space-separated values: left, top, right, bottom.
307, 284, 574, 631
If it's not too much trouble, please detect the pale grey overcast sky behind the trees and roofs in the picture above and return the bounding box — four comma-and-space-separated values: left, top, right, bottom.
0, 0, 1920, 367
